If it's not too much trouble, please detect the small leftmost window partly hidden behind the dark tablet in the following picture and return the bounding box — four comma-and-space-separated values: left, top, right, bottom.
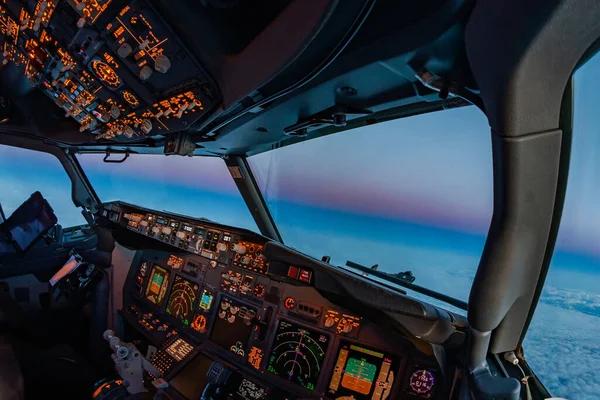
0, 145, 87, 227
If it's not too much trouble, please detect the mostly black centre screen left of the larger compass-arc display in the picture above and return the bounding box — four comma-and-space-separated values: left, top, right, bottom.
210, 297, 256, 358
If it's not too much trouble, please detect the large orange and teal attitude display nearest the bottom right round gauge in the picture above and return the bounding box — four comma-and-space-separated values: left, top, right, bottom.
328, 342, 400, 400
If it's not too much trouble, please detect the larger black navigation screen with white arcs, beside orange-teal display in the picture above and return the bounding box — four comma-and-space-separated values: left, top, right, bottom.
267, 320, 329, 390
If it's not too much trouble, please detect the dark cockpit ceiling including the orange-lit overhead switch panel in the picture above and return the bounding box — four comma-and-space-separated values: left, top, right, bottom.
0, 0, 474, 155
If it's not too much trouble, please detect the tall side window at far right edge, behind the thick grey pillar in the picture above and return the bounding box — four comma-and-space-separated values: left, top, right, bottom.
523, 50, 600, 400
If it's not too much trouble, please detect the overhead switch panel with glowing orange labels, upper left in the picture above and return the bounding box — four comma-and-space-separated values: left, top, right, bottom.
0, 0, 219, 142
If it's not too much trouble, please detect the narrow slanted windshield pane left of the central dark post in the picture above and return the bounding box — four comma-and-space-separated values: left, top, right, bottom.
78, 154, 258, 232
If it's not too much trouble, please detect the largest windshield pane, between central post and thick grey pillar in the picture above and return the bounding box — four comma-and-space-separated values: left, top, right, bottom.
249, 107, 493, 301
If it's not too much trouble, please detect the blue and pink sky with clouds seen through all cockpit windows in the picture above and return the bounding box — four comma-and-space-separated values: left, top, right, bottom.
0, 56, 600, 400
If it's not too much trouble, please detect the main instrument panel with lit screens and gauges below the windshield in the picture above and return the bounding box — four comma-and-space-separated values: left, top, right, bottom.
100, 203, 443, 400
